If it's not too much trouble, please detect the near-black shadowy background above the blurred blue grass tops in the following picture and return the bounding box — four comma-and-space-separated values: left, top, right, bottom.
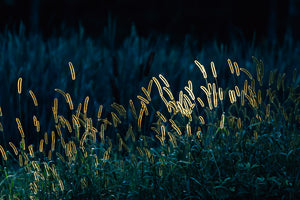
0, 0, 300, 42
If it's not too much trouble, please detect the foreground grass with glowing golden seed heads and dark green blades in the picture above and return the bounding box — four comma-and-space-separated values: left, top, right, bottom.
0, 50, 300, 199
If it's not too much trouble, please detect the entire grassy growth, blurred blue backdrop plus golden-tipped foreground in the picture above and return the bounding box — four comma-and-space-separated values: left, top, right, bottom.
0, 26, 300, 199
